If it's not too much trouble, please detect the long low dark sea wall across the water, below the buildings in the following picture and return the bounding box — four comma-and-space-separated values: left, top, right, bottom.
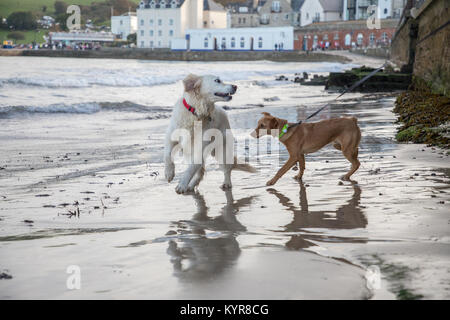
0, 48, 351, 63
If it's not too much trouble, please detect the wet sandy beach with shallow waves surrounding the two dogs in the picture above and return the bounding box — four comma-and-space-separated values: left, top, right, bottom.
0, 55, 450, 299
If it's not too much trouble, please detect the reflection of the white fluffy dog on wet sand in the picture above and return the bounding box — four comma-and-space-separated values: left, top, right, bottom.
167, 190, 255, 281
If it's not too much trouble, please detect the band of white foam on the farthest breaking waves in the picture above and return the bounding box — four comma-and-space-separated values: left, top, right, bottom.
0, 62, 353, 88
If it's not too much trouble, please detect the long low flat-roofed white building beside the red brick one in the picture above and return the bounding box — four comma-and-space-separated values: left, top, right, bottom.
172, 27, 294, 51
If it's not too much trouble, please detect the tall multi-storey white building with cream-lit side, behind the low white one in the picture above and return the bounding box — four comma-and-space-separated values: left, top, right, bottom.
136, 0, 227, 48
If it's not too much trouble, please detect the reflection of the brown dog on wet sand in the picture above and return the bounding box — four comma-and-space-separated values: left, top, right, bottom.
267, 181, 367, 250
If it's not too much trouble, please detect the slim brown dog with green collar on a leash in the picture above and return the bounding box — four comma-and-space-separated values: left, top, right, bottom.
251, 112, 361, 186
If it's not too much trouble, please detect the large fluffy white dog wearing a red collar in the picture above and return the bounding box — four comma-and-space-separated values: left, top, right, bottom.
164, 74, 255, 193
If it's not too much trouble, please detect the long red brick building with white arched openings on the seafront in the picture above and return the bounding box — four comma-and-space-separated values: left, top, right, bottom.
294, 19, 398, 50
